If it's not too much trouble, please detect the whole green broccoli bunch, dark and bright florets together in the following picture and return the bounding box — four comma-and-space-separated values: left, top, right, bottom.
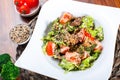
0, 53, 20, 80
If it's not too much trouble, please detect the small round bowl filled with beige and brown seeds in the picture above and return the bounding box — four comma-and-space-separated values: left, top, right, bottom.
10, 25, 30, 44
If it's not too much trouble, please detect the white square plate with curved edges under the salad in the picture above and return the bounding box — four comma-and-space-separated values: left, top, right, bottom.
15, 0, 120, 80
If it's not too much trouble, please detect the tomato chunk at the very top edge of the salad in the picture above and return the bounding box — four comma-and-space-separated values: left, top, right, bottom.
60, 12, 72, 24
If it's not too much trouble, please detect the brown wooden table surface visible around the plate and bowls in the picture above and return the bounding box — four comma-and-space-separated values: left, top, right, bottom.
0, 0, 120, 58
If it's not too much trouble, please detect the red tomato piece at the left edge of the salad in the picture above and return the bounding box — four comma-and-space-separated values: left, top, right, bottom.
46, 41, 55, 56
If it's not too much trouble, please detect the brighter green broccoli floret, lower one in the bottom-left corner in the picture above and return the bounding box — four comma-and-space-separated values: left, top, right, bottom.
1, 61, 20, 80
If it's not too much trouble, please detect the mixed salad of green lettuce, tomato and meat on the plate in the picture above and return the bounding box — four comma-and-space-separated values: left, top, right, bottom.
43, 12, 104, 71
